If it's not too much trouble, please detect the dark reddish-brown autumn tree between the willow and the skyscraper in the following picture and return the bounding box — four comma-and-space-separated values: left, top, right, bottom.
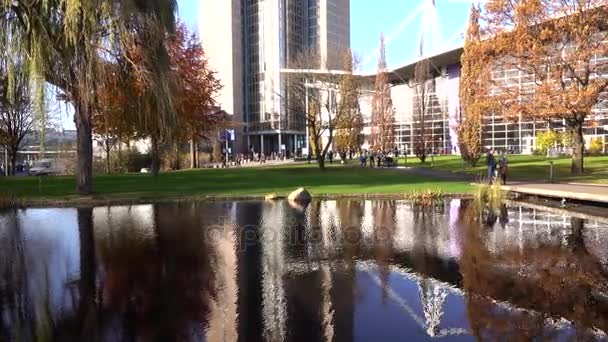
94, 23, 224, 174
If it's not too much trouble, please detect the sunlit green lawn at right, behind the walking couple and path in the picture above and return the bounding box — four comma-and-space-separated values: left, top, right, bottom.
399, 155, 608, 184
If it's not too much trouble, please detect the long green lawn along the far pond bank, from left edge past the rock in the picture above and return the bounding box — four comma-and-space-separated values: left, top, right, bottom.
0, 164, 472, 200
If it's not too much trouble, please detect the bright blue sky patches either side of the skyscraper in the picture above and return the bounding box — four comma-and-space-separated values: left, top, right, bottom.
178, 0, 471, 72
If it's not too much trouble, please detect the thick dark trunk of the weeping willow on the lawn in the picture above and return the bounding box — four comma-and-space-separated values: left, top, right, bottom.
74, 101, 93, 195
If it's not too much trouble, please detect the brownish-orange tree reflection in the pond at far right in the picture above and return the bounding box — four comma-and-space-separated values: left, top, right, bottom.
459, 203, 608, 340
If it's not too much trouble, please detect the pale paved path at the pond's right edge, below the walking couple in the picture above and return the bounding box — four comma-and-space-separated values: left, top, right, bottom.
502, 182, 608, 204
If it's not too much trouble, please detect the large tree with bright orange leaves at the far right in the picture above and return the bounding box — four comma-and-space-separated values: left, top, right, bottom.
476, 0, 608, 174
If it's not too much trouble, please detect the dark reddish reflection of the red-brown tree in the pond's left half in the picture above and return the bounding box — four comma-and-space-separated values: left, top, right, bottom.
97, 204, 217, 341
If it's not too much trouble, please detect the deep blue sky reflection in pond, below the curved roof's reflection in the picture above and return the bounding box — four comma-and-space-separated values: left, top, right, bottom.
354, 263, 474, 341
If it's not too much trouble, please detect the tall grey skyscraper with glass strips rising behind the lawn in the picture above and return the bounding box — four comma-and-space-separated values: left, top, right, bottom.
200, 0, 350, 154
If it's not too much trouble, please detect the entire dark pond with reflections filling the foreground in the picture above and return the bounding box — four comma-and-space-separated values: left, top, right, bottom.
0, 199, 608, 341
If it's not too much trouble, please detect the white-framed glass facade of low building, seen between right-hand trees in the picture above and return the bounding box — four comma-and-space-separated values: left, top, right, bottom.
364, 36, 608, 154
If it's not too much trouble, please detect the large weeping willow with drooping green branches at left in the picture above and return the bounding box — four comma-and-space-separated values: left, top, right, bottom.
0, 0, 177, 194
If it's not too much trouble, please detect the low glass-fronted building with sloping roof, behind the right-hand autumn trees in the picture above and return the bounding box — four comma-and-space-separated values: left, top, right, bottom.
361, 44, 608, 154
